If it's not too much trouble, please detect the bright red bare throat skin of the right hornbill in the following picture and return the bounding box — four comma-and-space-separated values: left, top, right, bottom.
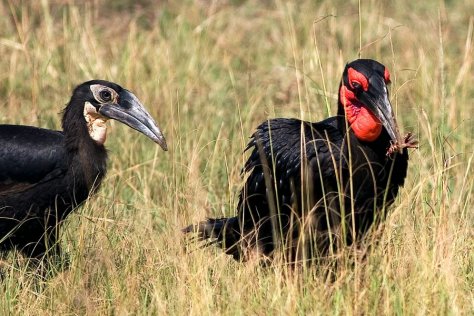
338, 85, 382, 142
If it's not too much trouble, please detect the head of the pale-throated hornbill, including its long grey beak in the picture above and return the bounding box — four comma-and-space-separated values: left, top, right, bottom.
63, 80, 168, 150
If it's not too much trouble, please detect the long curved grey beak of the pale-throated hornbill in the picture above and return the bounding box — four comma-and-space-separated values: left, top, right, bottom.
99, 89, 168, 151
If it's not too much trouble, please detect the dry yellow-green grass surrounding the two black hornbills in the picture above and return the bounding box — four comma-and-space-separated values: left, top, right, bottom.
0, 0, 474, 315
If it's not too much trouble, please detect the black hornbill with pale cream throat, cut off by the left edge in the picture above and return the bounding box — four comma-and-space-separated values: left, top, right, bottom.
0, 80, 167, 258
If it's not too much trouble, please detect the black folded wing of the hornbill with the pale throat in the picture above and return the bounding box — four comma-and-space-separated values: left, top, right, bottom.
0, 125, 67, 195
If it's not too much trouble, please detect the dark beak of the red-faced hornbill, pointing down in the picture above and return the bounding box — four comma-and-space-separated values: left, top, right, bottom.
358, 76, 401, 150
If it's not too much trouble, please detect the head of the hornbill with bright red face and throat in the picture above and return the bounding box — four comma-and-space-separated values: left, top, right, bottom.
339, 59, 401, 148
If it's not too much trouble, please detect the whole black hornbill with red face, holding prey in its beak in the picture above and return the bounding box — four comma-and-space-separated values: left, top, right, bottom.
183, 59, 416, 262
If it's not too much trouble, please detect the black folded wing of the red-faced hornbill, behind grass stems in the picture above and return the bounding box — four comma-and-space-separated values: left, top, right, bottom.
239, 117, 346, 220
